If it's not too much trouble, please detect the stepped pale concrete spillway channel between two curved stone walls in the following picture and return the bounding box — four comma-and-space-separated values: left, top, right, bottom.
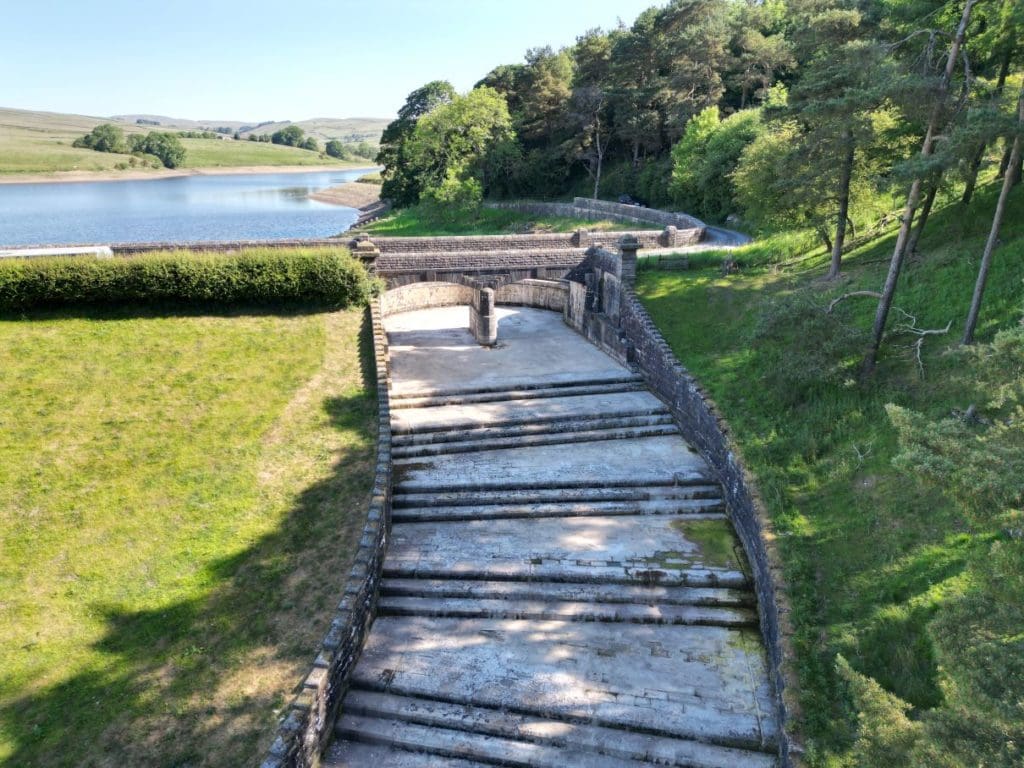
325, 307, 777, 768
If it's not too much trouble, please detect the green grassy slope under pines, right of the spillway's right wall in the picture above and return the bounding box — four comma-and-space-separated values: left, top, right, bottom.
638, 186, 1024, 766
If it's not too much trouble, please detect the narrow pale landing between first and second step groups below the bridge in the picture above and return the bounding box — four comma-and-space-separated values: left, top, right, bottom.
391, 392, 669, 439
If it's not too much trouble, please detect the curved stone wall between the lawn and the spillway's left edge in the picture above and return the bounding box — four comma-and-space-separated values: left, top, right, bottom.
261, 300, 391, 768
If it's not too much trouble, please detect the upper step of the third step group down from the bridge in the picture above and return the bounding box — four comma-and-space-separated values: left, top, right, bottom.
392, 484, 722, 509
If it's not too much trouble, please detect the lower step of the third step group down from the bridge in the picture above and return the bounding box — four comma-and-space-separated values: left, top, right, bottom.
391, 499, 726, 523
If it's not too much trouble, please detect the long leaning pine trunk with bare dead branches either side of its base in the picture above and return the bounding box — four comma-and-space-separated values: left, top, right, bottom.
862, 0, 976, 375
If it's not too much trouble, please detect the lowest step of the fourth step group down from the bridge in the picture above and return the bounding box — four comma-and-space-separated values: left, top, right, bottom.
377, 596, 757, 627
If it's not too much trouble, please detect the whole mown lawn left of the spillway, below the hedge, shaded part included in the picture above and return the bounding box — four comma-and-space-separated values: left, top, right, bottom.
0, 309, 376, 768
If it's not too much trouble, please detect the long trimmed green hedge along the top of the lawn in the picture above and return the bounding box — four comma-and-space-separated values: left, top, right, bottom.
0, 248, 375, 311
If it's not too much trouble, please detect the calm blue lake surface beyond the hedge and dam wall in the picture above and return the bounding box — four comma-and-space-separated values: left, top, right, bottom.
0, 168, 373, 246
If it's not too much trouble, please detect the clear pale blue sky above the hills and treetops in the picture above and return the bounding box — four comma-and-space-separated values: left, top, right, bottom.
0, 0, 664, 121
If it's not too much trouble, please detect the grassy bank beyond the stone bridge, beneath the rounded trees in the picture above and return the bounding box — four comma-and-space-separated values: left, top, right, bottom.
362, 206, 662, 238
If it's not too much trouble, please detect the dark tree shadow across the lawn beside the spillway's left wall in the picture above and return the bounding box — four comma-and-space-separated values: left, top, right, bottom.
0, 312, 376, 768
